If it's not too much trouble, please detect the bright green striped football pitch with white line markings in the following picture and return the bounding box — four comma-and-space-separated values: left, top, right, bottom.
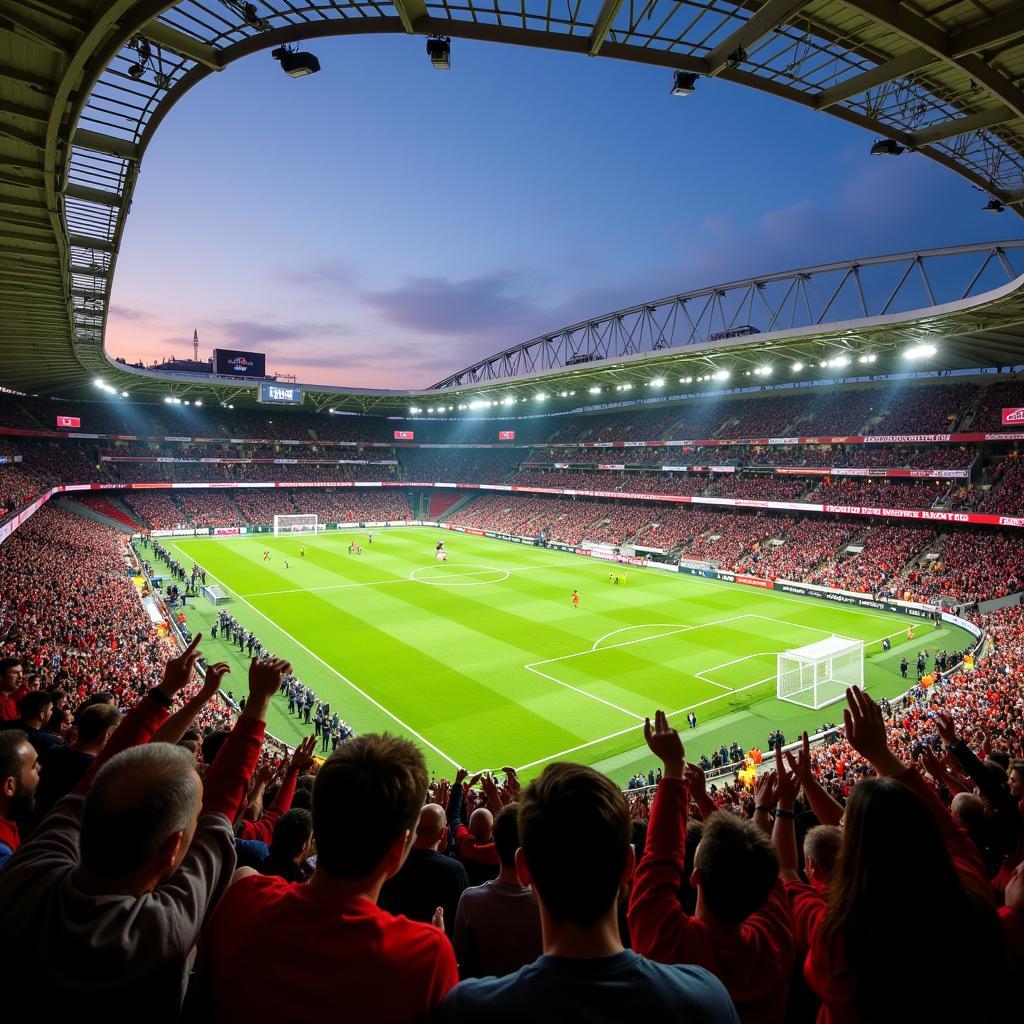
142, 527, 968, 780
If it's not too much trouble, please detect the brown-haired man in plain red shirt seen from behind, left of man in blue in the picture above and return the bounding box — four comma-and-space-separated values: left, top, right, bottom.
197, 734, 459, 1021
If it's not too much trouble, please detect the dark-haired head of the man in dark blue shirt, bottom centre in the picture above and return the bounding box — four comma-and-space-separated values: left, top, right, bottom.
519, 762, 633, 928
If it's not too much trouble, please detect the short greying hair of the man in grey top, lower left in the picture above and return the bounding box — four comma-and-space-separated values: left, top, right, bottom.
79, 743, 200, 879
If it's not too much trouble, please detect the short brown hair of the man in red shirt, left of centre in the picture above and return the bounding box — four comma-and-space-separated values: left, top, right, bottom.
313, 733, 427, 879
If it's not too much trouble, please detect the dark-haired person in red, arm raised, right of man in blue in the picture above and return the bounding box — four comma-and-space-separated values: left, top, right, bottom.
629, 712, 794, 1024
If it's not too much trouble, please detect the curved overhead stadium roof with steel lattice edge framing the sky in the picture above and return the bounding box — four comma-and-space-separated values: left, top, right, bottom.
0, 0, 1024, 409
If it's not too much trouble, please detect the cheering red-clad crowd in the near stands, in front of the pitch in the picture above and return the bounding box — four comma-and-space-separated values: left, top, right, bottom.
0, 495, 1024, 1024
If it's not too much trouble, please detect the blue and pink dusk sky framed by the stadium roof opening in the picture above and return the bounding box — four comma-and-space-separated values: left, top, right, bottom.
106, 36, 1017, 388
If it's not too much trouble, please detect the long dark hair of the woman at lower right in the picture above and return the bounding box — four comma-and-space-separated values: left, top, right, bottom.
820, 778, 1008, 1021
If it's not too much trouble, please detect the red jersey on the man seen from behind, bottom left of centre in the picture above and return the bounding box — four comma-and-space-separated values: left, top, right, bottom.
197, 874, 459, 1021
